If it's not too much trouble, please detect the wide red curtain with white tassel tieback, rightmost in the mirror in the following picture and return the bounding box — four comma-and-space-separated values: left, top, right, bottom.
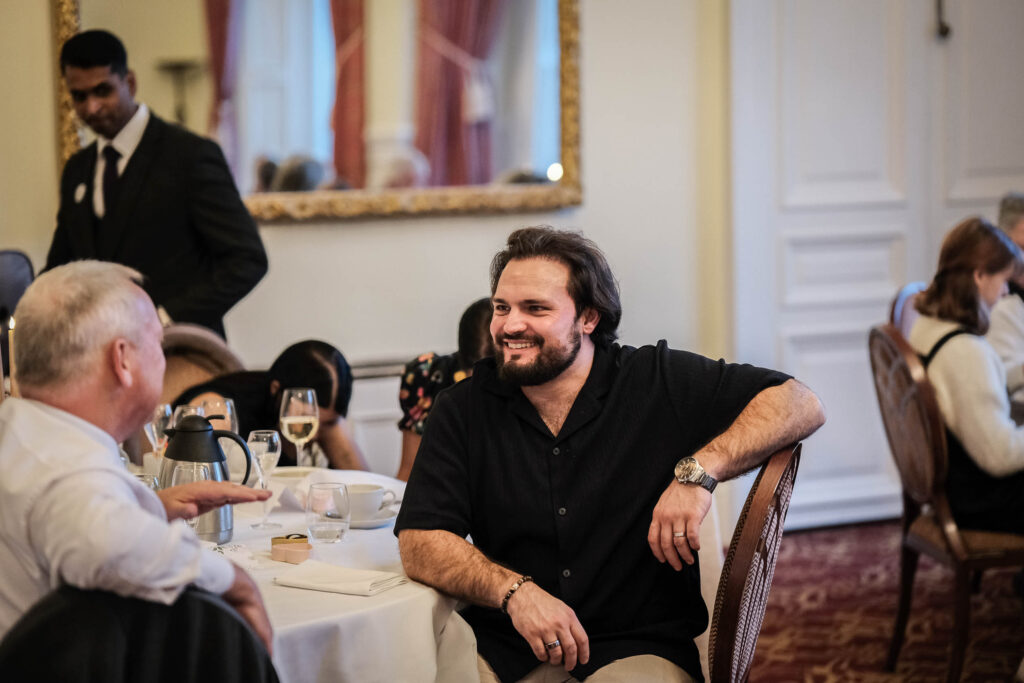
416, 0, 503, 185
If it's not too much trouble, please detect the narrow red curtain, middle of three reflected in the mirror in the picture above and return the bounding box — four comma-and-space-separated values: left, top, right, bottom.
331, 0, 367, 187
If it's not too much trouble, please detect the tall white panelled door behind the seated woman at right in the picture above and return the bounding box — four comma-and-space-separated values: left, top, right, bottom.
730, 0, 1024, 527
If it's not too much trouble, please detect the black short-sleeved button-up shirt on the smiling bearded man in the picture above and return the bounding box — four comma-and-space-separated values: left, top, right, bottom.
395, 341, 788, 681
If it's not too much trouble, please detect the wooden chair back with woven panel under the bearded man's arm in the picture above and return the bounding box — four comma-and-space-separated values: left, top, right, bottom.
708, 443, 801, 683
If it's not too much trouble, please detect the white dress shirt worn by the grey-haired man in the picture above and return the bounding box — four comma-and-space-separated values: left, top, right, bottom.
0, 398, 234, 637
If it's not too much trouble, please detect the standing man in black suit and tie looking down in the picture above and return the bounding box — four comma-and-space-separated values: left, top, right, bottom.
46, 31, 267, 336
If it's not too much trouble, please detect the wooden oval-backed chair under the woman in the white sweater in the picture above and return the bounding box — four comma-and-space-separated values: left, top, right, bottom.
868, 325, 1024, 682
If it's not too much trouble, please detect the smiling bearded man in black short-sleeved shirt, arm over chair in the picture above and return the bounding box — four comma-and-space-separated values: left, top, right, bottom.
395, 227, 824, 683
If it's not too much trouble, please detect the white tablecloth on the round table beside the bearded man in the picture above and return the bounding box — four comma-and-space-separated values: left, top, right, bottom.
231, 470, 477, 683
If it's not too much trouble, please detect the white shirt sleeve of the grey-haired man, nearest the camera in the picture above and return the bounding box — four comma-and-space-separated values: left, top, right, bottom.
28, 469, 234, 604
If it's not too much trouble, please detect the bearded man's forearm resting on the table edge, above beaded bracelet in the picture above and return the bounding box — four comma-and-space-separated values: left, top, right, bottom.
398, 529, 520, 608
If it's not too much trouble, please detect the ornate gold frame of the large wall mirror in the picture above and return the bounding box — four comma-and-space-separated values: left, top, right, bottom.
52, 0, 583, 221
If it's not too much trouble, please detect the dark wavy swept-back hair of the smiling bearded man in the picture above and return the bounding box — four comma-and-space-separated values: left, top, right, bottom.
490, 225, 623, 347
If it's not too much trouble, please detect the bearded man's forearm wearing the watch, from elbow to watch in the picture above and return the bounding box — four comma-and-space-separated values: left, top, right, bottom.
694, 380, 825, 480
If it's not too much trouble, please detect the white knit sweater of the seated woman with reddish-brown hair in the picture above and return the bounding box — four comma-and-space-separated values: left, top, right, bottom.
908, 315, 1024, 476
